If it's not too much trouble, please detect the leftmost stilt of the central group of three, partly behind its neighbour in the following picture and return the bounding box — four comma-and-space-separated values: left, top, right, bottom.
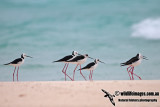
53, 51, 78, 81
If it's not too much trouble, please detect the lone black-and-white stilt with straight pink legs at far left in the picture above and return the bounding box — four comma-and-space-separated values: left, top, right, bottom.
4, 53, 32, 81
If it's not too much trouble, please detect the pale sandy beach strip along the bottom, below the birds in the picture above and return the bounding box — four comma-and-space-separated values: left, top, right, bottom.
0, 80, 160, 107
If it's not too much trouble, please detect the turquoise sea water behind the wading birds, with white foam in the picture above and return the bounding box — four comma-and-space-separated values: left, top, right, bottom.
0, 0, 160, 81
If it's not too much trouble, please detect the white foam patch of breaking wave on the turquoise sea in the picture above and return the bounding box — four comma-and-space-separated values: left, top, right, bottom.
132, 18, 160, 39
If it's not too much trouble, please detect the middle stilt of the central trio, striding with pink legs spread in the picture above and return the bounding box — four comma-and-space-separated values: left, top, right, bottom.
67, 54, 94, 81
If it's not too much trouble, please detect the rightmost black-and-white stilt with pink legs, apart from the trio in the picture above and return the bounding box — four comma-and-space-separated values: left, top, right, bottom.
121, 53, 148, 80
